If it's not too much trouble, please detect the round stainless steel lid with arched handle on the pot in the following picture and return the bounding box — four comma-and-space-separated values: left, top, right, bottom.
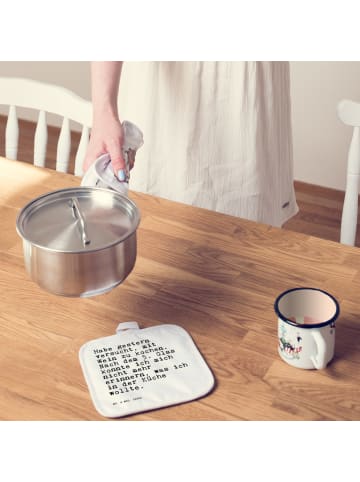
16, 187, 140, 253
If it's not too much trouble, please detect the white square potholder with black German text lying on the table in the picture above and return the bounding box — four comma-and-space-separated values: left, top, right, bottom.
79, 322, 214, 418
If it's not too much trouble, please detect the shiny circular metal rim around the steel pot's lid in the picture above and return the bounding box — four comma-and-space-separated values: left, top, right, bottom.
16, 186, 141, 255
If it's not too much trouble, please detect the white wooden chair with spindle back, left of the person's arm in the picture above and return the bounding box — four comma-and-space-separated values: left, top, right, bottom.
0, 77, 92, 176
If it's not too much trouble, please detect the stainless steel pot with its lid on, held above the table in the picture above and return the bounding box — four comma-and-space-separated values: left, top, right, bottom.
16, 187, 140, 297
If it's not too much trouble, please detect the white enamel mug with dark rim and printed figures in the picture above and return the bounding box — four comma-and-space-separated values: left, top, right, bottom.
274, 288, 340, 369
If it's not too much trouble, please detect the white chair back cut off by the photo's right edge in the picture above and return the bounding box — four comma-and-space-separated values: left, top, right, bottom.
337, 100, 360, 246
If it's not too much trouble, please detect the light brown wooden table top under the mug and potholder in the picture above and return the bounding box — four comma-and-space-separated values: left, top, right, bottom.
0, 158, 360, 420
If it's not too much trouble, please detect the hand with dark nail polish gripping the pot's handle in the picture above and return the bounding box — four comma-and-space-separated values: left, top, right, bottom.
83, 113, 129, 181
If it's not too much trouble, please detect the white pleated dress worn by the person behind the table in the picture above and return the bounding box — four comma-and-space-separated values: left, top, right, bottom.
119, 61, 298, 226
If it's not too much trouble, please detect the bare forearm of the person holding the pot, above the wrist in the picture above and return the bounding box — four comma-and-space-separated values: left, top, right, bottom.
91, 62, 122, 118
